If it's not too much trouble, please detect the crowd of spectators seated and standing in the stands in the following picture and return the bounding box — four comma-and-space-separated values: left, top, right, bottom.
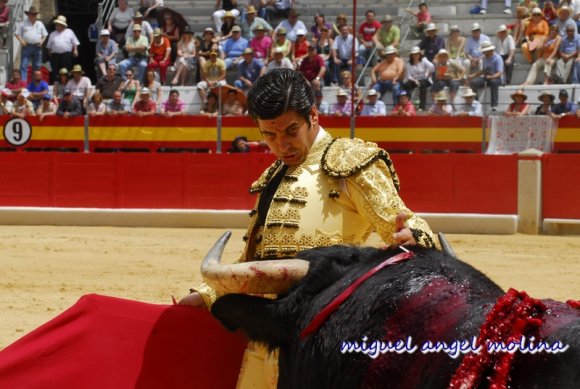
0, 0, 580, 116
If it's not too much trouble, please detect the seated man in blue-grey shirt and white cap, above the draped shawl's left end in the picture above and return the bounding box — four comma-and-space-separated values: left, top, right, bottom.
467, 41, 504, 112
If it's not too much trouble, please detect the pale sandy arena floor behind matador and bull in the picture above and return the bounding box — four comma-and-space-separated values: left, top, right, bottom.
0, 226, 580, 349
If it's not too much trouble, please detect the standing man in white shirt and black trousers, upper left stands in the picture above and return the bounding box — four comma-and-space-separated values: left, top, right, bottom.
46, 15, 80, 81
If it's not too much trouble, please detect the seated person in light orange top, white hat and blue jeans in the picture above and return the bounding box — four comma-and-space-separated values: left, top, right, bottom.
371, 46, 405, 105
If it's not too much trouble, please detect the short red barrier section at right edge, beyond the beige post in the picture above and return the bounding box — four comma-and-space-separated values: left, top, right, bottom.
542, 154, 580, 219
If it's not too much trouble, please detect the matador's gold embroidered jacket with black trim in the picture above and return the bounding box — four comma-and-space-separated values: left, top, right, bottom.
196, 128, 435, 306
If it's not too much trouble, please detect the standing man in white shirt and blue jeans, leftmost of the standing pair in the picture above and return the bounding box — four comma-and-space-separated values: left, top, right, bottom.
14, 7, 48, 80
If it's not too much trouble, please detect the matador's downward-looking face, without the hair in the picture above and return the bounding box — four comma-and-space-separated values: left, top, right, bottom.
258, 107, 319, 166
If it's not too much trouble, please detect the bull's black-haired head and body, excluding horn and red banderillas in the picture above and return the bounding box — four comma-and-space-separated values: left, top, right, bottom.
212, 246, 580, 388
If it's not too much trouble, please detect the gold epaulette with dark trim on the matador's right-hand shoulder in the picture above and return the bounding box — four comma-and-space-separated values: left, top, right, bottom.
321, 138, 399, 191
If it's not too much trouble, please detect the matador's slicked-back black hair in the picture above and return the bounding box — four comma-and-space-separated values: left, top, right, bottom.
248, 69, 314, 123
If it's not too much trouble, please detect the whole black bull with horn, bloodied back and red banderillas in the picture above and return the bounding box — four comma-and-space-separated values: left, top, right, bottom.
202, 235, 580, 388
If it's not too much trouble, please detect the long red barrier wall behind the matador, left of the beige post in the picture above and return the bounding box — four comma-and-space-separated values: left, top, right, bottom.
0, 152, 517, 214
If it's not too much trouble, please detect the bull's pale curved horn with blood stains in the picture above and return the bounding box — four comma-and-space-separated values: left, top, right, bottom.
201, 231, 308, 294
